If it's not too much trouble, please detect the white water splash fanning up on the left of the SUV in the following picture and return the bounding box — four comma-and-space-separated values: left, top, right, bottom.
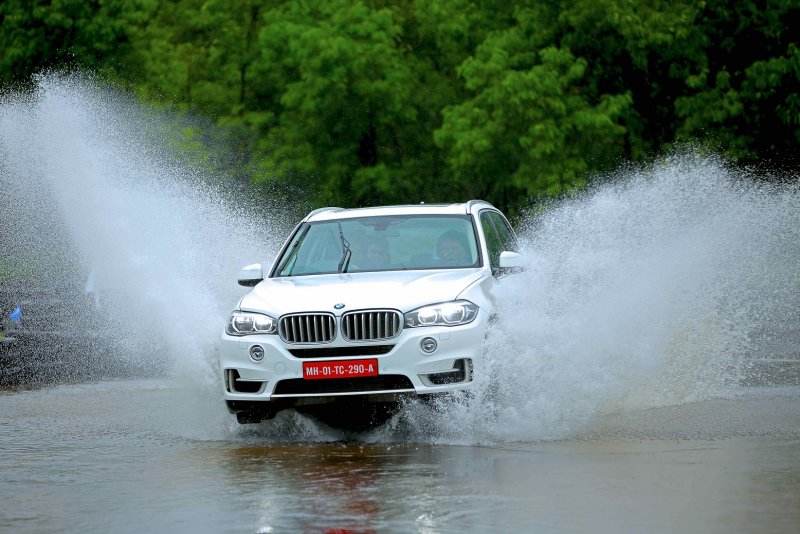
0, 75, 282, 391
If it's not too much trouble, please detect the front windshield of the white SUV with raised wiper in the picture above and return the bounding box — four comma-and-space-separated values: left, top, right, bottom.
274, 215, 481, 276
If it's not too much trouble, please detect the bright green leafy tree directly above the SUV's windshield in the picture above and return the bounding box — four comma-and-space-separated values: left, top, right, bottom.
253, 0, 438, 205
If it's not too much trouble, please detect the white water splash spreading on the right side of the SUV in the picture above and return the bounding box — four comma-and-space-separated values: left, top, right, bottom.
412, 153, 800, 441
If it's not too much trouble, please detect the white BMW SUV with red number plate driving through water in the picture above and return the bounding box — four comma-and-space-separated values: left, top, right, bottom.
220, 200, 522, 423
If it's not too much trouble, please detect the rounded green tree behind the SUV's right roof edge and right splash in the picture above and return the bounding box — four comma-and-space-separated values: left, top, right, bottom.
435, 3, 631, 205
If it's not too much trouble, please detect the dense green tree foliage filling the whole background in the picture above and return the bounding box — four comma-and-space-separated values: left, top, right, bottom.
0, 0, 800, 211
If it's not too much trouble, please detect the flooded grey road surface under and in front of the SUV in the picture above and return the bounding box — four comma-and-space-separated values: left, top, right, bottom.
0, 379, 800, 533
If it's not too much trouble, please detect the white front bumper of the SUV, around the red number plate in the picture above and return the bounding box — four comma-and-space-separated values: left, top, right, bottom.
220, 311, 488, 412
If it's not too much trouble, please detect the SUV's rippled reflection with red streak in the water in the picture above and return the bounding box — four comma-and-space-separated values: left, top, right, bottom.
224, 443, 436, 533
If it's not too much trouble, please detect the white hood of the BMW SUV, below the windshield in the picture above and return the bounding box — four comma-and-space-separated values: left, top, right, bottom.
239, 269, 488, 317
